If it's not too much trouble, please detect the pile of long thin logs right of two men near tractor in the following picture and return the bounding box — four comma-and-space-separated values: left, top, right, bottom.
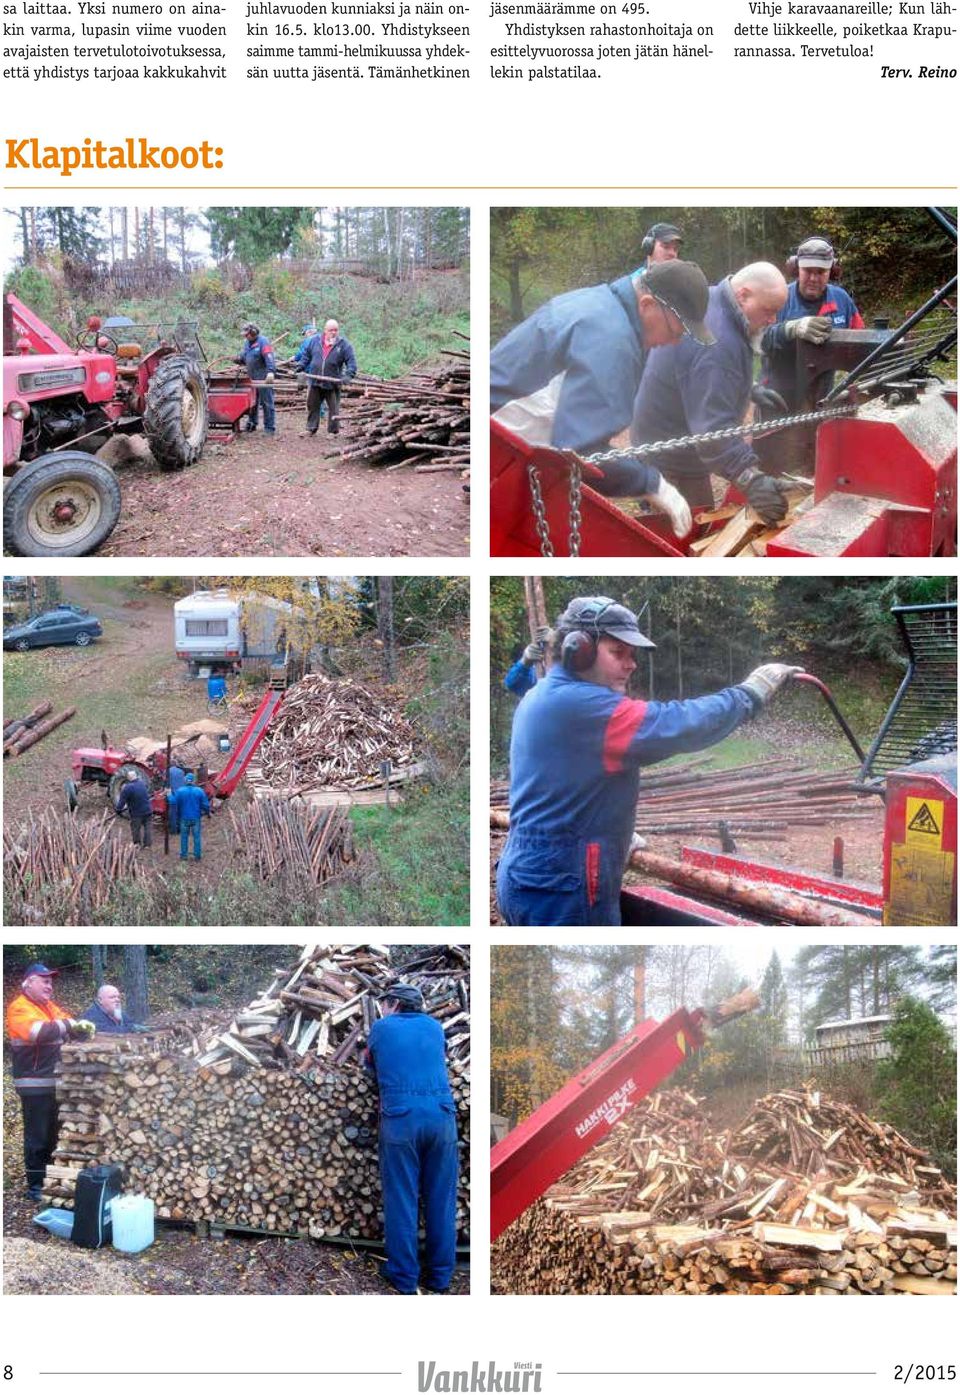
343, 353, 470, 473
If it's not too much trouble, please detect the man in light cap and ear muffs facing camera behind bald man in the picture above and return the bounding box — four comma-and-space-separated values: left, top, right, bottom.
760, 237, 864, 412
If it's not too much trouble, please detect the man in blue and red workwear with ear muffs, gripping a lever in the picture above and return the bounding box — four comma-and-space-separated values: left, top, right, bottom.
497, 596, 798, 925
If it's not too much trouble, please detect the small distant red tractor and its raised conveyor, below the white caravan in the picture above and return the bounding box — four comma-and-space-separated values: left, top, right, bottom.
64, 670, 286, 815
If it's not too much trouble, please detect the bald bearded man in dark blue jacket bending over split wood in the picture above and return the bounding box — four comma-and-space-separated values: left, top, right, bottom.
631, 262, 787, 525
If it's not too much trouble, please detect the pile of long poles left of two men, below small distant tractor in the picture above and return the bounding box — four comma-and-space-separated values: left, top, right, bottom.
3, 809, 144, 925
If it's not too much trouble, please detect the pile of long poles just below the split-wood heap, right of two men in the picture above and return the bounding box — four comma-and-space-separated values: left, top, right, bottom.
227, 799, 356, 886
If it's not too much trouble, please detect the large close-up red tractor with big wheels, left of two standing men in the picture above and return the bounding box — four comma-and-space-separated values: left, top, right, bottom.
3, 294, 255, 557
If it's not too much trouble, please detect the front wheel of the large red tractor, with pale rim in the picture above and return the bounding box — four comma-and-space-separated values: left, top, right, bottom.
3, 451, 120, 557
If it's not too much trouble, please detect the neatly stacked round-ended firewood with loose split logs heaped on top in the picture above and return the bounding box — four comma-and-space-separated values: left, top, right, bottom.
45, 944, 470, 1240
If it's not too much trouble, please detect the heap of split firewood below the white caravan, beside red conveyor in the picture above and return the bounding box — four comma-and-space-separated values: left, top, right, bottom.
250, 674, 416, 792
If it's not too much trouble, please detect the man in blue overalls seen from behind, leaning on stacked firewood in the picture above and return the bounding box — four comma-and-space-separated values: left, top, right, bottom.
367, 983, 458, 1293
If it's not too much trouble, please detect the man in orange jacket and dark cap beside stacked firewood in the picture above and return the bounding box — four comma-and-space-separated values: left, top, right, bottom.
7, 964, 96, 1201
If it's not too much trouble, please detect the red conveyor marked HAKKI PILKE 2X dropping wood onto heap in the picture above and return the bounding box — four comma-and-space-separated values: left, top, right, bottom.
490, 989, 759, 1240
